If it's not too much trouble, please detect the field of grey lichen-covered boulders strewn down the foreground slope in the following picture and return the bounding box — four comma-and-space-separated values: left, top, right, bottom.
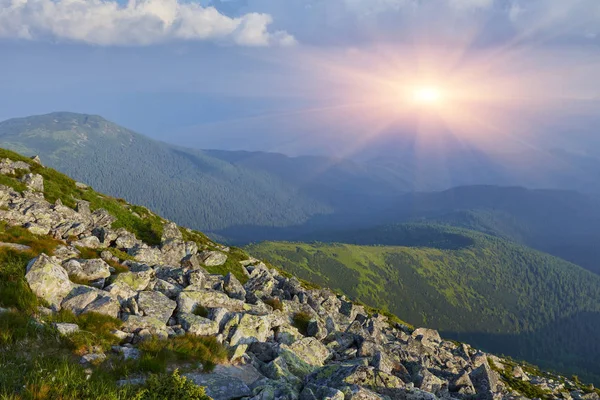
0, 150, 599, 400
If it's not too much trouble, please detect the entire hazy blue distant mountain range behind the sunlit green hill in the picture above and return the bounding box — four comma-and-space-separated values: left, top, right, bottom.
0, 113, 600, 272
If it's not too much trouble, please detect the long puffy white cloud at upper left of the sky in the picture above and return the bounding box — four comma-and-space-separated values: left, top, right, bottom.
0, 0, 295, 46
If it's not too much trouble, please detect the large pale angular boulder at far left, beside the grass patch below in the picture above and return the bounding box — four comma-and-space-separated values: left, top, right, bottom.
25, 254, 73, 311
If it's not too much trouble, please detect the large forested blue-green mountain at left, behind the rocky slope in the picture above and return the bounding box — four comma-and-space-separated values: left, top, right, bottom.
0, 113, 404, 231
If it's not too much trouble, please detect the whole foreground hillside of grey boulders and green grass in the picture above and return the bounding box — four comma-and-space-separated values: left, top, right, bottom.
0, 149, 600, 400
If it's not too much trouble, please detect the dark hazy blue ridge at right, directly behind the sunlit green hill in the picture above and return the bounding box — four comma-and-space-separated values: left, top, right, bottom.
380, 186, 600, 272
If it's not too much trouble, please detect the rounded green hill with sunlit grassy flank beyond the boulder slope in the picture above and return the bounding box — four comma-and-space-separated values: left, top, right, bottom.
246, 224, 600, 379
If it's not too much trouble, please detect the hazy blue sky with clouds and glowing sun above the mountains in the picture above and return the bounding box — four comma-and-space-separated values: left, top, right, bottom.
0, 0, 600, 157
